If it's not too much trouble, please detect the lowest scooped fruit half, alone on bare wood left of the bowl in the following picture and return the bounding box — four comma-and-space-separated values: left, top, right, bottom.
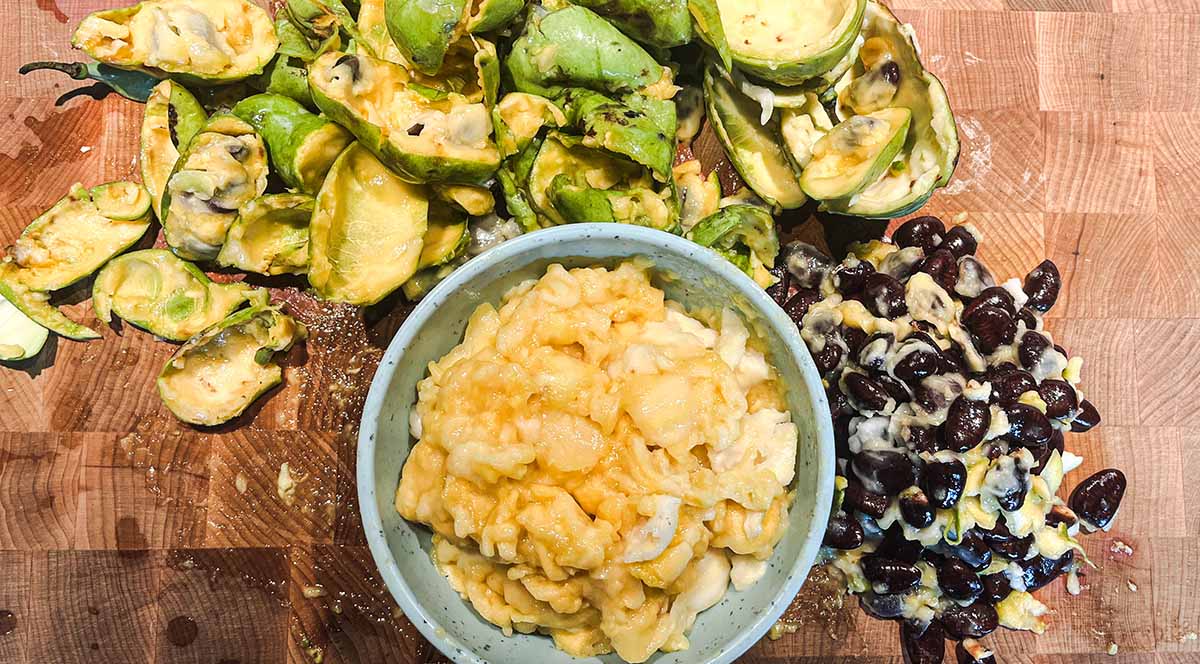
158, 306, 307, 426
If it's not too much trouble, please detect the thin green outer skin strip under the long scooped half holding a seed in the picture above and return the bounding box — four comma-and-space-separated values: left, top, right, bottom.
310, 55, 500, 185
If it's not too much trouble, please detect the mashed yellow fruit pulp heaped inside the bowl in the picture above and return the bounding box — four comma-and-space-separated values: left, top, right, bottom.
396, 263, 797, 662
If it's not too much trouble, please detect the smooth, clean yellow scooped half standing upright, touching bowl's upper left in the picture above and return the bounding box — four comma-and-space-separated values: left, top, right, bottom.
308, 143, 430, 306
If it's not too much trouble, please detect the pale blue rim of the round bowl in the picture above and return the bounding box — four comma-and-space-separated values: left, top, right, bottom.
355, 223, 835, 664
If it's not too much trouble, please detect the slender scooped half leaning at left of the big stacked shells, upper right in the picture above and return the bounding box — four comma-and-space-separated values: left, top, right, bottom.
704, 67, 808, 209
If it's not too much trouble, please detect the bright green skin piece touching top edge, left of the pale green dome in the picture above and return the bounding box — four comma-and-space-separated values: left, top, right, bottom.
384, 0, 468, 76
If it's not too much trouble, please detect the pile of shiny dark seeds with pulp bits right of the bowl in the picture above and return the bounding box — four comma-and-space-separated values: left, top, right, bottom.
774, 216, 1126, 662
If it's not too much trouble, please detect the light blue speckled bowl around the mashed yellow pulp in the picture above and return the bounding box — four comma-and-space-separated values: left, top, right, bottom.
358, 223, 834, 664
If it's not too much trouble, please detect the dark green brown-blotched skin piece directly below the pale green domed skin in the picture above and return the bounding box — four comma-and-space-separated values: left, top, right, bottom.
560, 88, 676, 183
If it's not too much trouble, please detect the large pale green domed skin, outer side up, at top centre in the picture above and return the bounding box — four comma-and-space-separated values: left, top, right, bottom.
504, 6, 662, 98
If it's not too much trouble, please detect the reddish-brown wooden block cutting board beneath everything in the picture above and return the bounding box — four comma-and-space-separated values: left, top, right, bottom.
0, 0, 1200, 664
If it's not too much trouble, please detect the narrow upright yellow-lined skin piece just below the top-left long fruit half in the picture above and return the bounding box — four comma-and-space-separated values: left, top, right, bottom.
139, 79, 209, 219
